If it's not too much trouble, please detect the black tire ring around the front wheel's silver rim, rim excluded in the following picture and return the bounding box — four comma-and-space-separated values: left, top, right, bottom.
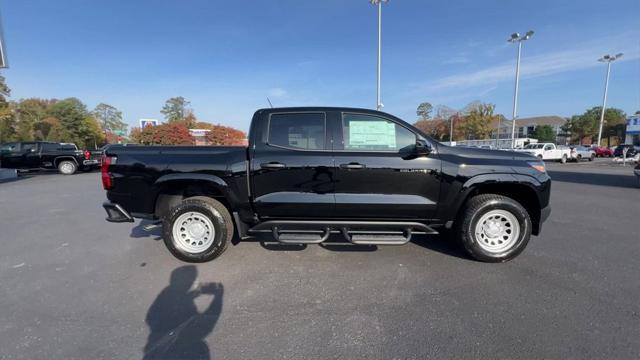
461, 198, 531, 262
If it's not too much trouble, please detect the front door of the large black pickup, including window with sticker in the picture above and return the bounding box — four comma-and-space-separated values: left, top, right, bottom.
334, 112, 441, 219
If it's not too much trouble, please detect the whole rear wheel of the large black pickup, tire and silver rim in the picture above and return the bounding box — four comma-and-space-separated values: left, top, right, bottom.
163, 196, 234, 262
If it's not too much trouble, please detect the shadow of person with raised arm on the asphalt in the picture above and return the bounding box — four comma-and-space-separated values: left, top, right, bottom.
143, 265, 224, 359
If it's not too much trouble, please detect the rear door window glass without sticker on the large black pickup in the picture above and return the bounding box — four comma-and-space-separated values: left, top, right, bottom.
268, 113, 326, 150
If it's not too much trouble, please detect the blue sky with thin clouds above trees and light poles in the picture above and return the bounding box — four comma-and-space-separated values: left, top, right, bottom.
0, 0, 640, 131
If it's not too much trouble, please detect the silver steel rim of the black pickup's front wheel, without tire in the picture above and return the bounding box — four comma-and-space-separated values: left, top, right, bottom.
474, 209, 520, 253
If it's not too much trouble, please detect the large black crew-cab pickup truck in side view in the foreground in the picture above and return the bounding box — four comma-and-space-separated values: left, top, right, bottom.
102, 107, 551, 262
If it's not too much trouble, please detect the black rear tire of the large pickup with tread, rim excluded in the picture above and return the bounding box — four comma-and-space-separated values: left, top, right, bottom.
163, 196, 234, 263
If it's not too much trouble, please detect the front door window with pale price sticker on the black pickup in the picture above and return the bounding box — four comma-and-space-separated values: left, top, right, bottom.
342, 114, 416, 152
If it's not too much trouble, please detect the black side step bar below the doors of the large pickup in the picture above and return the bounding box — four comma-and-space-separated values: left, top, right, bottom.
248, 220, 438, 245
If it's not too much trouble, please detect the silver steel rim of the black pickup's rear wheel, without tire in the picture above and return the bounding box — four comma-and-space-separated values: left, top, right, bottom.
172, 211, 216, 254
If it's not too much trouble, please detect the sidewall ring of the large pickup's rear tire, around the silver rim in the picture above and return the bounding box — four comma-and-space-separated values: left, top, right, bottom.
163, 200, 228, 262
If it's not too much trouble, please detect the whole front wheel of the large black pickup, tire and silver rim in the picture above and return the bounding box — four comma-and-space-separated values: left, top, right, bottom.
457, 194, 531, 262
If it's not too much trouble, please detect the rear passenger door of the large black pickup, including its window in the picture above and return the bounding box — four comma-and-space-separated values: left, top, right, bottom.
249, 111, 334, 218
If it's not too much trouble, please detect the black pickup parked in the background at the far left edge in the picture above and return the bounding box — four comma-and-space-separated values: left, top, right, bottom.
0, 141, 99, 175
